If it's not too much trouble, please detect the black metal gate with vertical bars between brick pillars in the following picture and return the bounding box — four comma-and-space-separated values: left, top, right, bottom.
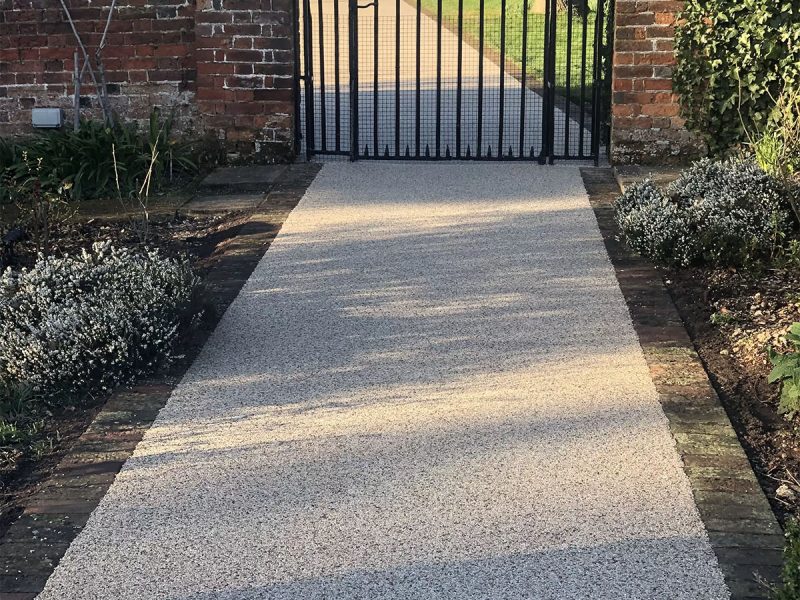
296, 0, 613, 163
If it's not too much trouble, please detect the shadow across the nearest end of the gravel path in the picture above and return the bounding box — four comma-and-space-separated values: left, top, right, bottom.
176, 537, 732, 600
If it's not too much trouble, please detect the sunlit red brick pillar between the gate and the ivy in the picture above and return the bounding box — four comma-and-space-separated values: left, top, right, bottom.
611, 0, 703, 164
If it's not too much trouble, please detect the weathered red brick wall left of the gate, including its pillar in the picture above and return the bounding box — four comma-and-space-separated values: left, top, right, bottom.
0, 0, 294, 161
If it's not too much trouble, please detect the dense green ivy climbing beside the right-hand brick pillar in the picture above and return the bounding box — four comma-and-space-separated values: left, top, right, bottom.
674, 0, 800, 155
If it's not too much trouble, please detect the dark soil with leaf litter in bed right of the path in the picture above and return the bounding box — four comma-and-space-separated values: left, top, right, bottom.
665, 269, 800, 521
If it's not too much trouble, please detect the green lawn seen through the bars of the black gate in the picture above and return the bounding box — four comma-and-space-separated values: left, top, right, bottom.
422, 0, 595, 102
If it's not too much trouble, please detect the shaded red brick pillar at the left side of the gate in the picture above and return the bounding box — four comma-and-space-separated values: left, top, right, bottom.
195, 0, 294, 162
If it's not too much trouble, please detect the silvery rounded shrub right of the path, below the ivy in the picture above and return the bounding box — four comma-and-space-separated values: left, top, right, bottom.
615, 158, 790, 266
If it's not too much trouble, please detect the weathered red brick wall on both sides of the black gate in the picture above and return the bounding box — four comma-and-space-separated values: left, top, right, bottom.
0, 0, 702, 163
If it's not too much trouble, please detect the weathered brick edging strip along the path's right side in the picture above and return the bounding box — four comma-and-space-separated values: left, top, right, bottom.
581, 169, 783, 600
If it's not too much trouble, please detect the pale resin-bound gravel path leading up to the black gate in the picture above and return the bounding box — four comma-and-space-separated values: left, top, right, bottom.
40, 163, 728, 600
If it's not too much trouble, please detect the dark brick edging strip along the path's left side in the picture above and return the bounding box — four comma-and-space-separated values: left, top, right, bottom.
0, 164, 319, 600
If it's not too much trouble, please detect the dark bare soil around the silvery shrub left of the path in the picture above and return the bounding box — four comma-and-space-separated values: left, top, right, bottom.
0, 213, 253, 536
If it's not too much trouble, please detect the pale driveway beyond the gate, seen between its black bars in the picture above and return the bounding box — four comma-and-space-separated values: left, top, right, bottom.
300, 0, 592, 158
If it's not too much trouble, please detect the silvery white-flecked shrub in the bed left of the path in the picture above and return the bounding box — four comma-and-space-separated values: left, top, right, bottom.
0, 243, 198, 397
